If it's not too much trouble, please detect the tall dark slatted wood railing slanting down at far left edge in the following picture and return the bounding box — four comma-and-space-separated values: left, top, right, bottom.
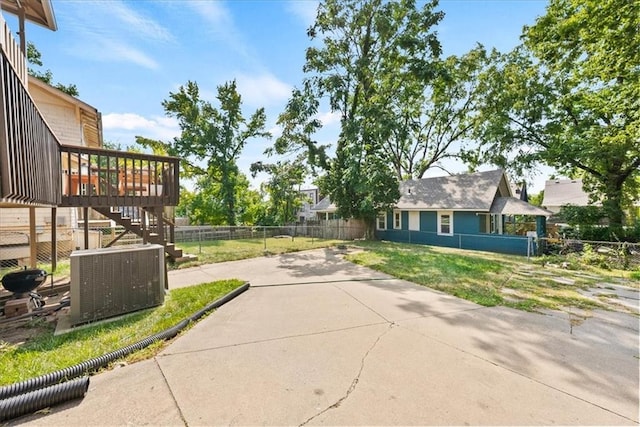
0, 20, 61, 206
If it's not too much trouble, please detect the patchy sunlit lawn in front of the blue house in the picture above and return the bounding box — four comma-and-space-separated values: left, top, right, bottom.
347, 241, 640, 311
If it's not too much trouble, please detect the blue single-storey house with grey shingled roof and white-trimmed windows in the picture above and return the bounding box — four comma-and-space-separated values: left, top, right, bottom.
376, 169, 551, 255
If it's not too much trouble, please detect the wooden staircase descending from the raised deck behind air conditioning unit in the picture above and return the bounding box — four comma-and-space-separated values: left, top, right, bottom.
93, 207, 183, 261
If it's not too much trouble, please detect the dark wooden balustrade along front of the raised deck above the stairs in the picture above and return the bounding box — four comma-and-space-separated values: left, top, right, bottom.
60, 145, 180, 208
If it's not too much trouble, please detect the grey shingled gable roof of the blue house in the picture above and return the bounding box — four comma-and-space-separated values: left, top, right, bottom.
397, 169, 512, 212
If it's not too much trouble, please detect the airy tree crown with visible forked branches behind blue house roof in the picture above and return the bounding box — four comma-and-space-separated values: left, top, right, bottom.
378, 46, 487, 180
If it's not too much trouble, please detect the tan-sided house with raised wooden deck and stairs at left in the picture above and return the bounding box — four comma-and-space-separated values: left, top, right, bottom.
0, 0, 182, 268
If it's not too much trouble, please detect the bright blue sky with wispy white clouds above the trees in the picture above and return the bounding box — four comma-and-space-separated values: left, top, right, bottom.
5, 0, 550, 193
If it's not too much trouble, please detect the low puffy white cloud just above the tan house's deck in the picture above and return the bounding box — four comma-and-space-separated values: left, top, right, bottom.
102, 113, 180, 142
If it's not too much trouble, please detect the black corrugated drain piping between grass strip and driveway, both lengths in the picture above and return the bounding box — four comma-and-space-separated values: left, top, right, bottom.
0, 282, 250, 421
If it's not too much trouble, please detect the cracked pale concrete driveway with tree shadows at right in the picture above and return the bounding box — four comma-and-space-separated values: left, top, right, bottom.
11, 249, 639, 426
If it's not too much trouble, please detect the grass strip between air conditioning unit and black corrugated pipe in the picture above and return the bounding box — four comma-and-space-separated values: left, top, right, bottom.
0, 280, 243, 385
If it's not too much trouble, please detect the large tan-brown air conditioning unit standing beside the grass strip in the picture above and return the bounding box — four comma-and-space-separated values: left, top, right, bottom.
69, 245, 165, 325
